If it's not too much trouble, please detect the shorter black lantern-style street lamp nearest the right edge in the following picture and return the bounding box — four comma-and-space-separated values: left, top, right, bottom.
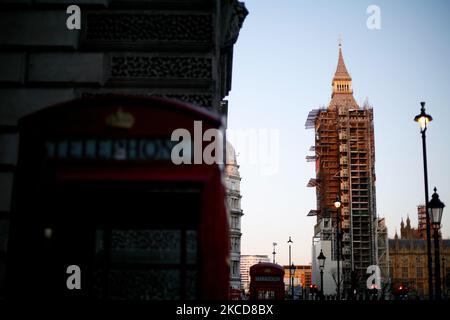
428, 187, 445, 300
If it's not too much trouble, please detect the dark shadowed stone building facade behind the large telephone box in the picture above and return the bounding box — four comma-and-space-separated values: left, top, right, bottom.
0, 0, 248, 295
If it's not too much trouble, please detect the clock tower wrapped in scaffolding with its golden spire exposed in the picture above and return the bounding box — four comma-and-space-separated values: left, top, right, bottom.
305, 46, 378, 295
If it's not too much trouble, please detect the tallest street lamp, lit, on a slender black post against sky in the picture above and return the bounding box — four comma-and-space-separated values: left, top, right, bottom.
414, 102, 433, 300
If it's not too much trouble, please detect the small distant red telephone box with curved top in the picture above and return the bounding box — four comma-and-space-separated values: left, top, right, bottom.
250, 262, 284, 300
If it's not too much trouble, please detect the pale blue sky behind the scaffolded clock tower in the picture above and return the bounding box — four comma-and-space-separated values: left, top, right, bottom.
228, 0, 450, 264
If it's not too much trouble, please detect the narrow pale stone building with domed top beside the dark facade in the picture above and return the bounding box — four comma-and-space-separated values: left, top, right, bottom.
225, 142, 244, 290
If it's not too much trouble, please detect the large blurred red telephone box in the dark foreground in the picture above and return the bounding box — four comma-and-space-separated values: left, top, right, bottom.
7, 95, 229, 300
